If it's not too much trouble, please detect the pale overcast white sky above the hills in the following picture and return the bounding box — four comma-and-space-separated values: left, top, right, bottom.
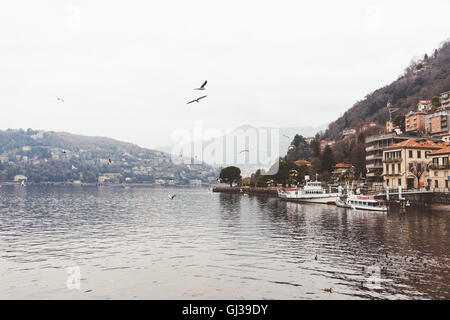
0, 0, 450, 148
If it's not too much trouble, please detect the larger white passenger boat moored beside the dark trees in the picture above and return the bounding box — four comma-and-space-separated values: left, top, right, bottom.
278, 181, 339, 204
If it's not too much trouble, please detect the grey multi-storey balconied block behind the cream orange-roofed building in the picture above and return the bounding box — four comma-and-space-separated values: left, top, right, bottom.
365, 132, 409, 187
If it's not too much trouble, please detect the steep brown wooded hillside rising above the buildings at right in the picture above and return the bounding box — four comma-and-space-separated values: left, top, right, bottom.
322, 41, 450, 140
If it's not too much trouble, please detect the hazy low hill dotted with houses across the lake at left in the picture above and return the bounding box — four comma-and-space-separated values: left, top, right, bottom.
0, 129, 218, 185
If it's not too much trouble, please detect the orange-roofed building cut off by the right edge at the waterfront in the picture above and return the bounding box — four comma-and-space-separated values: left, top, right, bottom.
428, 145, 450, 192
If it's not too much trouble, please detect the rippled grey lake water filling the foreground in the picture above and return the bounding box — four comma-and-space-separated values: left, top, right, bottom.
0, 185, 450, 299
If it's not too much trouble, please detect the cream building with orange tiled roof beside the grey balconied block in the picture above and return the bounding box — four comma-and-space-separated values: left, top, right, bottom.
383, 139, 445, 189
